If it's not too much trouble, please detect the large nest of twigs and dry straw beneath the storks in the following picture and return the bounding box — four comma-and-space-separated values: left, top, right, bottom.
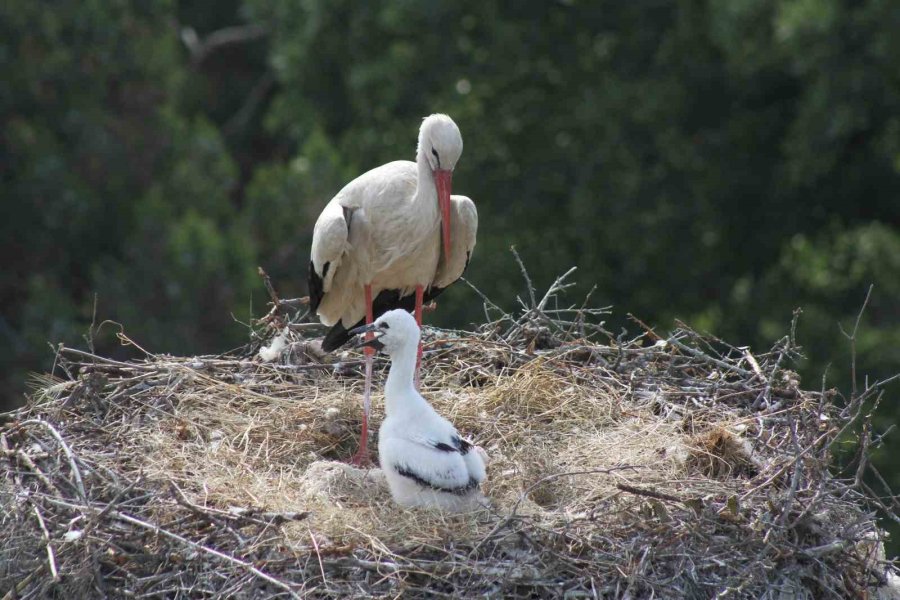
0, 270, 895, 600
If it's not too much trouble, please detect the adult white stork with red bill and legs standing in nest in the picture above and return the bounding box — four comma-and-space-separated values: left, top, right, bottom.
308, 114, 478, 463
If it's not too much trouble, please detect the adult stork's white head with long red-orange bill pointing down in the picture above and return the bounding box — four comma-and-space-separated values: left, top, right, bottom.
418, 114, 462, 255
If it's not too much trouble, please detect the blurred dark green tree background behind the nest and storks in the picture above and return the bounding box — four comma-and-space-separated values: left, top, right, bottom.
0, 0, 900, 548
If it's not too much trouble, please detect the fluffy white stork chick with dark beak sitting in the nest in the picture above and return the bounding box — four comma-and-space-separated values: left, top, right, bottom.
350, 309, 486, 511
